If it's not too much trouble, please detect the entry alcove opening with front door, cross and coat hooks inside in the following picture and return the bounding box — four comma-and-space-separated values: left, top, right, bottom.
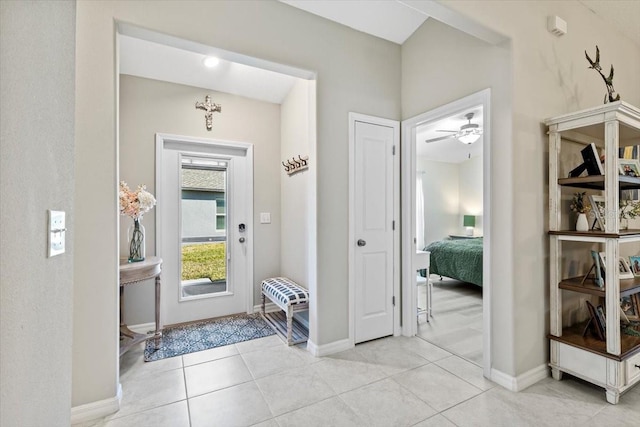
117, 23, 317, 352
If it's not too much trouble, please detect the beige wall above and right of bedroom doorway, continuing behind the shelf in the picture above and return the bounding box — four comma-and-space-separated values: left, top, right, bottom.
402, 1, 640, 376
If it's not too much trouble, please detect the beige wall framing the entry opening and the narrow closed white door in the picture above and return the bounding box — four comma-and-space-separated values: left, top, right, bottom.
73, 1, 400, 405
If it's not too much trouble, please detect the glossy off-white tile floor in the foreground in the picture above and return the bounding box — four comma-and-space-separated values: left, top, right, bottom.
78, 336, 640, 427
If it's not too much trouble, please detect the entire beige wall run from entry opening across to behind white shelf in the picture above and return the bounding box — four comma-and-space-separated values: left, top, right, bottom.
73, 1, 640, 412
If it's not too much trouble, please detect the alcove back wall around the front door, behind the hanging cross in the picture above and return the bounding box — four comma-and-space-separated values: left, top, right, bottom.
119, 75, 282, 325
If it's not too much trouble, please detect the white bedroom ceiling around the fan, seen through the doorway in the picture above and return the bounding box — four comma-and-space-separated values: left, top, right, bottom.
416, 105, 483, 163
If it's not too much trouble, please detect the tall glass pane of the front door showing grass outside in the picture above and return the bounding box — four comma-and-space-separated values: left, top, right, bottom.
180, 156, 232, 300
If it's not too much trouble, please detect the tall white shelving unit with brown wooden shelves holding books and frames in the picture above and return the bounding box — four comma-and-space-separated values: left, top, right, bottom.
545, 101, 640, 404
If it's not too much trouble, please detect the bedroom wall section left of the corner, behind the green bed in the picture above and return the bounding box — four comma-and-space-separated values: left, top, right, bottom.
416, 158, 460, 249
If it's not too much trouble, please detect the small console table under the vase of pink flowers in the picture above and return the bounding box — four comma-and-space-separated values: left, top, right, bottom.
120, 256, 162, 356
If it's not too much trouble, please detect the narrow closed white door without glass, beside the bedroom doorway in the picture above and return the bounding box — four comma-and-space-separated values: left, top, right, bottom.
352, 120, 398, 343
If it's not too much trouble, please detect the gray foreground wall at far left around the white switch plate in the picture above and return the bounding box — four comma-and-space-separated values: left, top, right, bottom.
0, 1, 76, 427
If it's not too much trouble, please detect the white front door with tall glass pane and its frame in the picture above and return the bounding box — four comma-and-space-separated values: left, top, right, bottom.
156, 135, 253, 325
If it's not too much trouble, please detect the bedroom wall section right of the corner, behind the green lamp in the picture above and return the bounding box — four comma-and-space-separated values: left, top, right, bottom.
458, 154, 483, 236
